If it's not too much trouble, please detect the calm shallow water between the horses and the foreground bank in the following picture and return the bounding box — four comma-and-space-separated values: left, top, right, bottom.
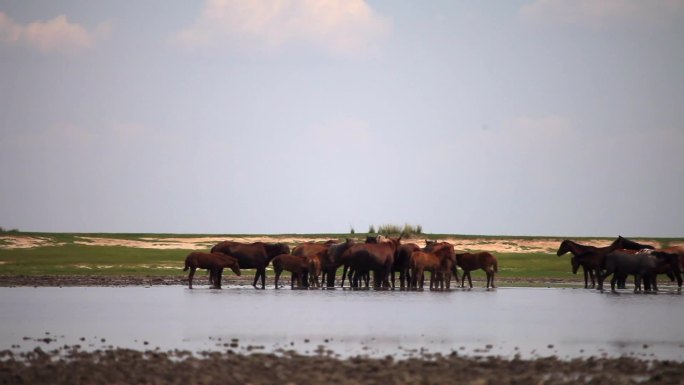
0, 286, 684, 361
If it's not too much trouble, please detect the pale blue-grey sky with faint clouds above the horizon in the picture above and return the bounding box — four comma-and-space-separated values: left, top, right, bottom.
0, 0, 684, 237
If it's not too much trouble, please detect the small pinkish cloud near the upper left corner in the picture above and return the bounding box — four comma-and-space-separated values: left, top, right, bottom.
0, 12, 111, 54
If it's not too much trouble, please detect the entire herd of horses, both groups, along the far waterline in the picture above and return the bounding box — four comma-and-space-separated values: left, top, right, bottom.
184, 234, 684, 291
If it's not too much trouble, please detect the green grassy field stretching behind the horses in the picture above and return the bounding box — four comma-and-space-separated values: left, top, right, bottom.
0, 233, 682, 282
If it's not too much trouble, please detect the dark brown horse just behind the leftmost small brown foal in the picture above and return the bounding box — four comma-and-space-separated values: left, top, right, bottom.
211, 241, 290, 289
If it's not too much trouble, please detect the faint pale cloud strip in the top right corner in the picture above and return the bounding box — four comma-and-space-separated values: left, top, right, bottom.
519, 0, 684, 27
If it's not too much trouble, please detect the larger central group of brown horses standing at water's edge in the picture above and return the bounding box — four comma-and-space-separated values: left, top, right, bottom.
183, 234, 498, 290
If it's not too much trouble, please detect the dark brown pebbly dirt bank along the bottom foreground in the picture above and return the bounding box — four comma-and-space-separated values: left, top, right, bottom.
0, 348, 684, 385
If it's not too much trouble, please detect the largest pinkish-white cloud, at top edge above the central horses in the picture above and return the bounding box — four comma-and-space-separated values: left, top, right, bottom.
173, 0, 390, 56
